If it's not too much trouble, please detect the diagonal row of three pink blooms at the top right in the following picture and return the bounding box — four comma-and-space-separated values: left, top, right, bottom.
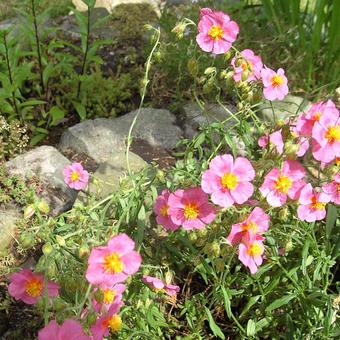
196, 8, 288, 100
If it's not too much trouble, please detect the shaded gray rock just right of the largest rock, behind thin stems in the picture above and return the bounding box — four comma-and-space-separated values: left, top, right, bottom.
183, 103, 236, 138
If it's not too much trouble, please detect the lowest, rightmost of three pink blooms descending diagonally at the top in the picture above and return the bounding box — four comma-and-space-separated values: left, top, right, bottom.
261, 67, 288, 100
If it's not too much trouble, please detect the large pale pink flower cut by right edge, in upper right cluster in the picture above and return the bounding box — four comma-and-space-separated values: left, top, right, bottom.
312, 109, 340, 163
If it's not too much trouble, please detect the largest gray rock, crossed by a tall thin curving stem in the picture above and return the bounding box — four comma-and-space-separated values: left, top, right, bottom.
59, 108, 182, 163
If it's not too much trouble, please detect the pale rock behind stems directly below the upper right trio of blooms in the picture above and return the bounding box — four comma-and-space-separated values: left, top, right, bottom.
258, 95, 311, 121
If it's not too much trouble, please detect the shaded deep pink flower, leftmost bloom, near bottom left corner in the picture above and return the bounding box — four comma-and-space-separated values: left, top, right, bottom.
8, 269, 59, 305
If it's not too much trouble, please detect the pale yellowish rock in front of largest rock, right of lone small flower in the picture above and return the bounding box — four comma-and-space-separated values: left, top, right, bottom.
79, 152, 147, 201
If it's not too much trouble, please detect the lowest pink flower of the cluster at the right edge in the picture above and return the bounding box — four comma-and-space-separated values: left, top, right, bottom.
297, 183, 330, 222
